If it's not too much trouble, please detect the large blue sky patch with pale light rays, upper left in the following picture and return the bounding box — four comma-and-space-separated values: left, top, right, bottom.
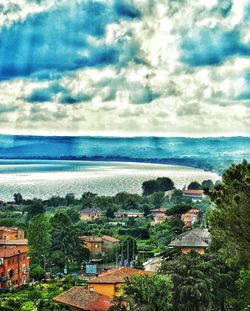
0, 1, 139, 80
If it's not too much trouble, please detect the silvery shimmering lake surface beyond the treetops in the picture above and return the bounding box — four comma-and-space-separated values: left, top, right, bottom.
0, 160, 220, 201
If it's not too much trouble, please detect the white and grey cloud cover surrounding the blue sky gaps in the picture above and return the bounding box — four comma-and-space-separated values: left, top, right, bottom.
0, 0, 250, 136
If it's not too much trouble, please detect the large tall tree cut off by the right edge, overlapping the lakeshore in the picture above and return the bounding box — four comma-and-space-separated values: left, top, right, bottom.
209, 161, 250, 266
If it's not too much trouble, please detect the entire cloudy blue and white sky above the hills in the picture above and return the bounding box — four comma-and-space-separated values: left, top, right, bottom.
0, 0, 250, 137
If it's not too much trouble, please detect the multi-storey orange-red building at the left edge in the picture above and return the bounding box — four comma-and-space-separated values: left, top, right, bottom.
0, 227, 30, 288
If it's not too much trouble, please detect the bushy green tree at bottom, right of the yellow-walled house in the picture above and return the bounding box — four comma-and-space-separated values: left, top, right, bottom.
124, 274, 173, 311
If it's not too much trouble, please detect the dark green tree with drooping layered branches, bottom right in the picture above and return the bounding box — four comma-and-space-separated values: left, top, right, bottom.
161, 252, 236, 311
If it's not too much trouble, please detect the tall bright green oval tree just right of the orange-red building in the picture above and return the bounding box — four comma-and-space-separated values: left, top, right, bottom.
28, 214, 51, 265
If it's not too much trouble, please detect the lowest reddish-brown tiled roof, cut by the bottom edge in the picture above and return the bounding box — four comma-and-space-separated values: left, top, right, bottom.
53, 286, 111, 311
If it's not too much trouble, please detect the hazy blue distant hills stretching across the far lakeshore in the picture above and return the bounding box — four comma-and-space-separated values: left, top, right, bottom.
0, 135, 250, 173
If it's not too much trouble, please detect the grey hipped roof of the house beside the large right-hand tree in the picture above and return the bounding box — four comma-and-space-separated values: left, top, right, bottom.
168, 228, 210, 248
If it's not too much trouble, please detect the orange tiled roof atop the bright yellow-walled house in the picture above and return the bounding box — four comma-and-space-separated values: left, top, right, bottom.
89, 267, 152, 284
